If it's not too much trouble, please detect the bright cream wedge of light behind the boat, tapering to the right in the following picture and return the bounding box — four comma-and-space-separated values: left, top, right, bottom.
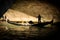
4, 9, 51, 22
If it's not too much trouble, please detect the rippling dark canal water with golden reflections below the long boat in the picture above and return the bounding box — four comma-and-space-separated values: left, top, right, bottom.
0, 22, 57, 40
